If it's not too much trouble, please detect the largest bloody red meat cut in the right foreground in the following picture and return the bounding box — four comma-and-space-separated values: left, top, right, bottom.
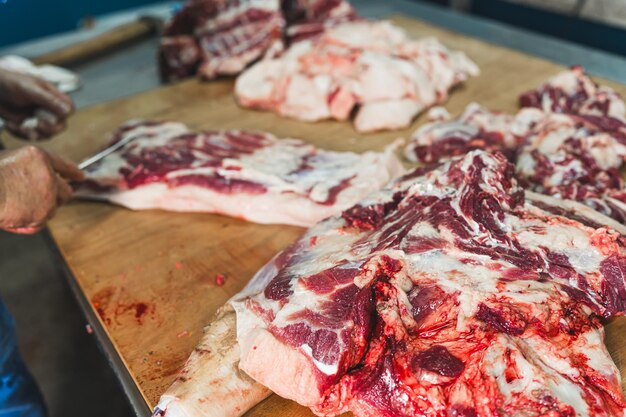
232, 151, 626, 417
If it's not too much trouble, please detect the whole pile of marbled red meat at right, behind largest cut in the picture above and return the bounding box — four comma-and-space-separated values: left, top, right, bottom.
406, 67, 626, 222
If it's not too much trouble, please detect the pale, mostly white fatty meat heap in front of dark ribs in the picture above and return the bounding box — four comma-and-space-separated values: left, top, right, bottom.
235, 21, 478, 132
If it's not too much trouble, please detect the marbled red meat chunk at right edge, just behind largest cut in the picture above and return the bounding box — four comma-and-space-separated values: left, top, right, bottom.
516, 109, 626, 223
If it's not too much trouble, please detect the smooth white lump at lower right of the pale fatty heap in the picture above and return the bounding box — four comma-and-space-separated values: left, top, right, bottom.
354, 99, 423, 132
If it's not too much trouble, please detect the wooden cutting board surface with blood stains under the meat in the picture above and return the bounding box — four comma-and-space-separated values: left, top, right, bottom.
4, 14, 626, 417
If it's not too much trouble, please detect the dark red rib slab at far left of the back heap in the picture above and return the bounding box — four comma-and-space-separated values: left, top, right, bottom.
159, 0, 285, 81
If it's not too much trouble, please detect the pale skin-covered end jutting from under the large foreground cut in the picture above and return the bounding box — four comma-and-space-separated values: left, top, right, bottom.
154, 304, 271, 417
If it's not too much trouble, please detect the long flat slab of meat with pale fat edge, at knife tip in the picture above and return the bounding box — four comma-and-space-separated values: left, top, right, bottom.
77, 121, 404, 226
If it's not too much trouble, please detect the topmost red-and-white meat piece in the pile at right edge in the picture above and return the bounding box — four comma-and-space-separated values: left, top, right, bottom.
519, 66, 626, 118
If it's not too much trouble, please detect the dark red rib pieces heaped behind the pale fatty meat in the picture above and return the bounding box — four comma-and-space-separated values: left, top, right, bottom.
159, 0, 357, 81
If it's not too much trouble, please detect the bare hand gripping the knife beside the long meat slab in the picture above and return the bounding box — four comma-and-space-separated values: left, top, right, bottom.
0, 146, 84, 233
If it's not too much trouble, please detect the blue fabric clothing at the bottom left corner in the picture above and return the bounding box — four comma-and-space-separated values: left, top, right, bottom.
0, 300, 46, 417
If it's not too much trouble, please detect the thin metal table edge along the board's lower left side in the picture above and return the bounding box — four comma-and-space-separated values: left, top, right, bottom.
42, 228, 152, 417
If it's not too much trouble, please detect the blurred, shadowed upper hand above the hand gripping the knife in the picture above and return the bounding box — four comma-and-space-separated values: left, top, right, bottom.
0, 69, 74, 140
